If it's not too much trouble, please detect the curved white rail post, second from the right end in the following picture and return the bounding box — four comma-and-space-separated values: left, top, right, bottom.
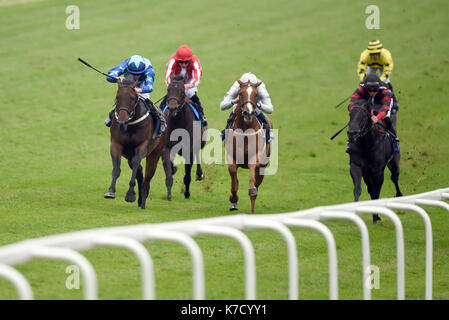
355, 206, 405, 300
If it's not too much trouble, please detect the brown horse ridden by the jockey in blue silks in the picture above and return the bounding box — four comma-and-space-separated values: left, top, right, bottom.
104, 79, 167, 209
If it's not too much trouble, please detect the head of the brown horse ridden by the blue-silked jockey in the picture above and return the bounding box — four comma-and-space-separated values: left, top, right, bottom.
115, 79, 139, 131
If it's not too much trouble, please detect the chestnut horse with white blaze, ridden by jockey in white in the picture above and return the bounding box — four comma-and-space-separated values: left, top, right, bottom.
225, 80, 273, 213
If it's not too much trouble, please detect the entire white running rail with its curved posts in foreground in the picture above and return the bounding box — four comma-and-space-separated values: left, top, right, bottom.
0, 188, 449, 300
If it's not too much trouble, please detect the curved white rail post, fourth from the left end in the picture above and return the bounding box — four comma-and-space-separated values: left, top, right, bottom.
144, 230, 206, 300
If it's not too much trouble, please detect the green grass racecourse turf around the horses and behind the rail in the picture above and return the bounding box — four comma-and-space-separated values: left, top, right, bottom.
0, 0, 449, 299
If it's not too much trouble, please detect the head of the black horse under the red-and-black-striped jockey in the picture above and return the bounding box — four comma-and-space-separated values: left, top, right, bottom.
348, 101, 372, 143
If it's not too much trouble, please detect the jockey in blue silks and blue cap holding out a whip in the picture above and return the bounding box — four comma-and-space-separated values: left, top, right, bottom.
104, 55, 166, 138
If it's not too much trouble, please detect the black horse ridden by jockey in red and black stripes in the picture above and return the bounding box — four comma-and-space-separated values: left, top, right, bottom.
348, 102, 402, 223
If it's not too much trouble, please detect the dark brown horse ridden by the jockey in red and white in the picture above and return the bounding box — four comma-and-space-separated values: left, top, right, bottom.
161, 75, 206, 201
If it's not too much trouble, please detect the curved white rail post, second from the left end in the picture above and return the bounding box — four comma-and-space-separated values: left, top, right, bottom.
29, 245, 98, 300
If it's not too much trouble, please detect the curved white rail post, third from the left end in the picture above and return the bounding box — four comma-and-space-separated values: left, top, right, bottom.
92, 235, 156, 300
